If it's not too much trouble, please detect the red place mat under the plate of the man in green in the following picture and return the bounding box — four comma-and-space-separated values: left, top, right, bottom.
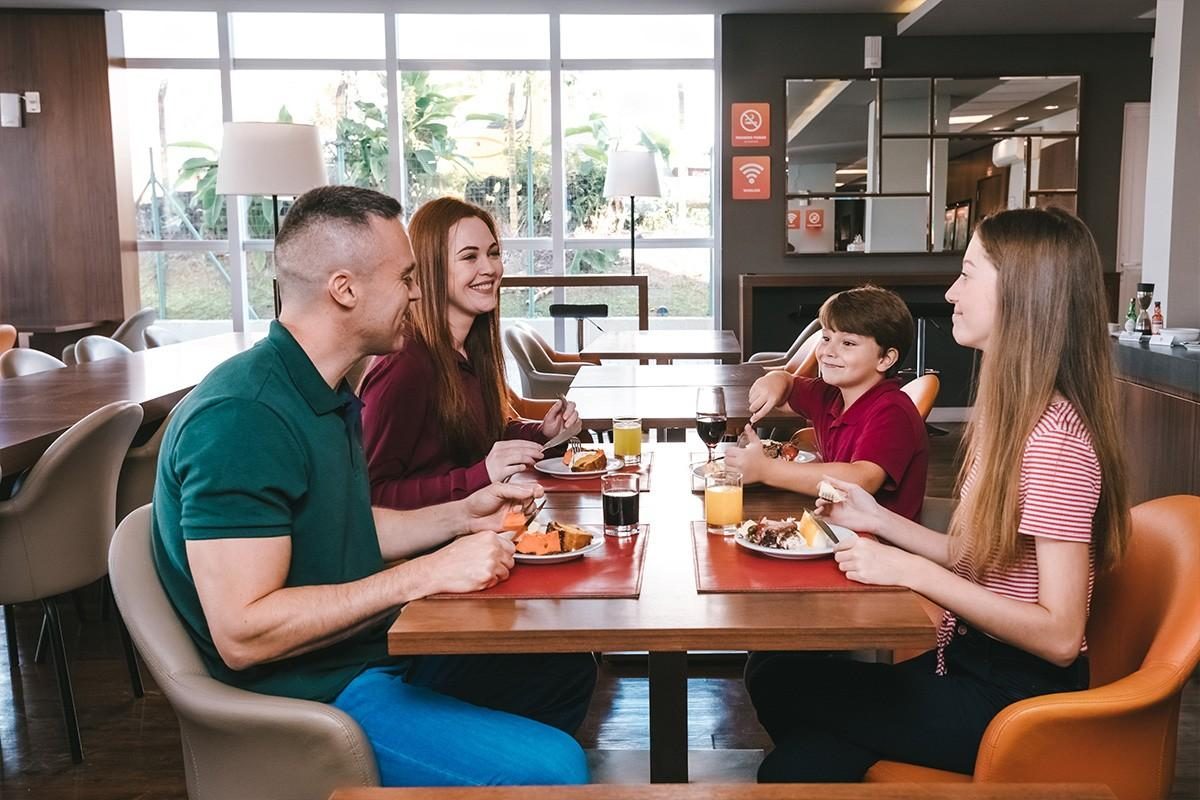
431, 524, 650, 600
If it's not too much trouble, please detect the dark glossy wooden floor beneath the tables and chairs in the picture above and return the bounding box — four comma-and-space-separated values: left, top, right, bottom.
0, 428, 1200, 800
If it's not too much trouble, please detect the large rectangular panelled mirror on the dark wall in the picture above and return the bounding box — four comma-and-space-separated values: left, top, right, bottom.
786, 76, 1079, 255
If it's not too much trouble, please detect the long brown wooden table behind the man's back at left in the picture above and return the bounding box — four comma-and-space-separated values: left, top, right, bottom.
0, 332, 266, 474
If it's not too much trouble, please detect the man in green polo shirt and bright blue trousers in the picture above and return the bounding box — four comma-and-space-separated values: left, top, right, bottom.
152, 186, 595, 786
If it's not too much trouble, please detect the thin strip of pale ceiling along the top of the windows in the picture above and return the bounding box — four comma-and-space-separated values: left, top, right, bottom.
0, 0, 920, 14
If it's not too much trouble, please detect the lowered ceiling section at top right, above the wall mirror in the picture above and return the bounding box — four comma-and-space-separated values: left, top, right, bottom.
896, 0, 1154, 36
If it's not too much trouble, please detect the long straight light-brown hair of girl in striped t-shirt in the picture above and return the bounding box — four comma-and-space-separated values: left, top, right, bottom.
949, 207, 1129, 573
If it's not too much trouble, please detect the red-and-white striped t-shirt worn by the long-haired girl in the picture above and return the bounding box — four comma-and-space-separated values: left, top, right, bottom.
937, 401, 1100, 674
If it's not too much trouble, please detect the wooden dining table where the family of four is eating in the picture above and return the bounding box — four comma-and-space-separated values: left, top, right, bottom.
388, 443, 934, 782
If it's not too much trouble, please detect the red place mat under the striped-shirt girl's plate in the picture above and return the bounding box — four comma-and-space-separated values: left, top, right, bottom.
691, 522, 895, 594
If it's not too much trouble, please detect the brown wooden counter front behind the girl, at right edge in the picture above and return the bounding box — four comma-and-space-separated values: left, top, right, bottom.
1117, 380, 1200, 504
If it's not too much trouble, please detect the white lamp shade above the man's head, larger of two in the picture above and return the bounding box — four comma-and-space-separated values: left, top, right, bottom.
217, 122, 329, 196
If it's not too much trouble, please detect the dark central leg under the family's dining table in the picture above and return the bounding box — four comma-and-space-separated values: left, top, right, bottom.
648, 652, 688, 783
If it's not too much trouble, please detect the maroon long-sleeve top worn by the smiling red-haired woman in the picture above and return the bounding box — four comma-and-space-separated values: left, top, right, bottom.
359, 338, 546, 509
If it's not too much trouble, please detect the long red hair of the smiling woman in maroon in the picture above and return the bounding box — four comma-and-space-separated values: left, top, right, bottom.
408, 197, 509, 464
